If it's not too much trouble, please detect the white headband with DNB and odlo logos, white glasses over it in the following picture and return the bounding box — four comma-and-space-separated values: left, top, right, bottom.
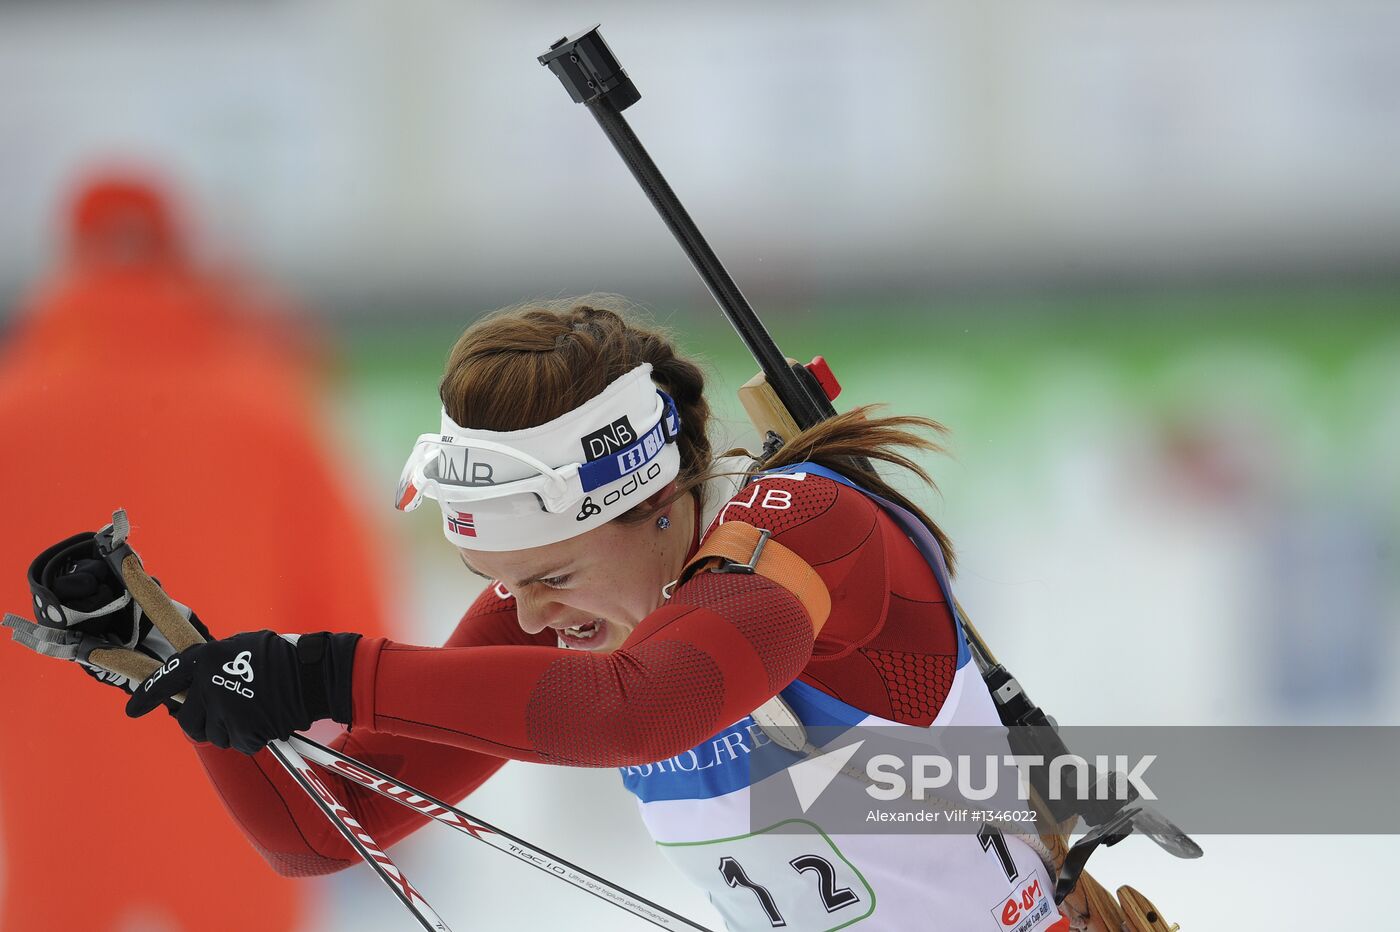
395, 362, 680, 550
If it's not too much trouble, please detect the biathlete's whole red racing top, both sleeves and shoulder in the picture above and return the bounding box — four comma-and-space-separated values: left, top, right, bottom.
197, 476, 958, 876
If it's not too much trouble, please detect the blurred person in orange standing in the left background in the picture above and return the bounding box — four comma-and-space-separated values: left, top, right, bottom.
0, 170, 386, 932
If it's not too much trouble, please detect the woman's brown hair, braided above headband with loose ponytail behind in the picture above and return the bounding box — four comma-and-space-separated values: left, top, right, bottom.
438, 295, 953, 568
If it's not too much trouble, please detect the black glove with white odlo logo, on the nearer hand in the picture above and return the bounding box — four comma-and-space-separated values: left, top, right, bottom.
126, 631, 360, 754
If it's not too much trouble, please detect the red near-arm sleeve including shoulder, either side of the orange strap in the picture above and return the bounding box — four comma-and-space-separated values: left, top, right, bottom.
354, 476, 956, 767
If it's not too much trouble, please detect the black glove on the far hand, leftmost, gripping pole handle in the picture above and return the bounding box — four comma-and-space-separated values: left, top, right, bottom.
3, 526, 209, 711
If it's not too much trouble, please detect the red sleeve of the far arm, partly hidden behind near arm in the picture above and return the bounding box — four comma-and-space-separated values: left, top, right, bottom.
196, 588, 552, 876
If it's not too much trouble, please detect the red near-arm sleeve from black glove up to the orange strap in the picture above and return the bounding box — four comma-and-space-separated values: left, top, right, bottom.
354, 572, 812, 767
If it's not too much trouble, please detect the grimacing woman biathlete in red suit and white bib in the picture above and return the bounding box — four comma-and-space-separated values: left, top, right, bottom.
32, 304, 1079, 932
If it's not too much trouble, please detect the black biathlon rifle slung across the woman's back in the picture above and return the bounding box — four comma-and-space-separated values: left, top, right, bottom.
539, 25, 1201, 932
